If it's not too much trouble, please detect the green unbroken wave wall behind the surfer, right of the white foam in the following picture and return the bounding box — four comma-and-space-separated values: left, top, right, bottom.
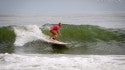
41, 24, 125, 41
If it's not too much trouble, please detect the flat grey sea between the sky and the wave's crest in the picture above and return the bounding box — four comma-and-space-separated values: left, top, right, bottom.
0, 12, 125, 28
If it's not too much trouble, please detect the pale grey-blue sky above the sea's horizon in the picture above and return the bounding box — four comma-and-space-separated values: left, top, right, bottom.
0, 0, 125, 13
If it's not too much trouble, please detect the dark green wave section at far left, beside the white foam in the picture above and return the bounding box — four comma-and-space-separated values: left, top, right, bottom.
0, 26, 16, 53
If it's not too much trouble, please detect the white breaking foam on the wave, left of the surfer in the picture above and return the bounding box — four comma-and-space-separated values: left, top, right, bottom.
14, 25, 49, 46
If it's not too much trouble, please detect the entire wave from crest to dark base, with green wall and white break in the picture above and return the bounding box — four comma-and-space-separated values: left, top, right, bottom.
0, 24, 125, 54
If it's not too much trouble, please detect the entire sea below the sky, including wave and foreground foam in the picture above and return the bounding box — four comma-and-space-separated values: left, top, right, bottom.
0, 13, 125, 70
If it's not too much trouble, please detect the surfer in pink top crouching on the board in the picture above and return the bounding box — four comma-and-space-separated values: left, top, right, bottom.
50, 22, 62, 40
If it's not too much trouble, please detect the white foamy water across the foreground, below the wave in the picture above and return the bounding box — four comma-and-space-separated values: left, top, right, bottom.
0, 54, 125, 70
